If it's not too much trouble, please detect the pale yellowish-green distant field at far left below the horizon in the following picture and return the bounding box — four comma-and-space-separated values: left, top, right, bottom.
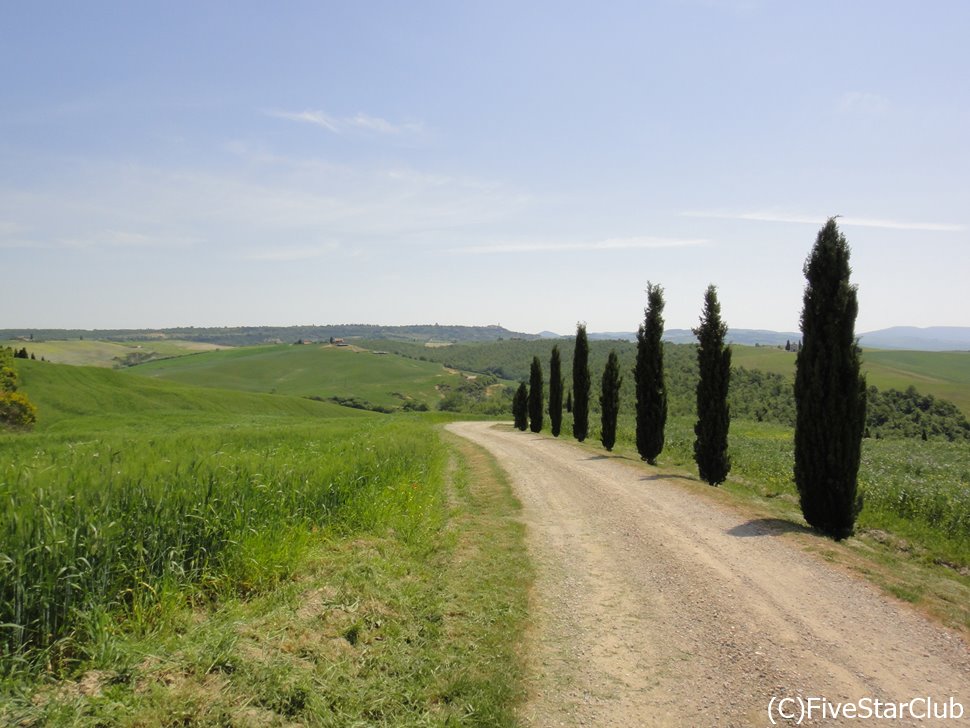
0, 339, 226, 367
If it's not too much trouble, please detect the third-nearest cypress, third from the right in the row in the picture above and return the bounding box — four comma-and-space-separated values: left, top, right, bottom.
633, 282, 667, 465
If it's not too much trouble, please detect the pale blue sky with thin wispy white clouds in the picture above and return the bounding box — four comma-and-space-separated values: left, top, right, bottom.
0, 0, 970, 334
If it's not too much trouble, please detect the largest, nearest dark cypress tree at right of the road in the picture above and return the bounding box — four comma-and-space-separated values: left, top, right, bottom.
795, 218, 866, 540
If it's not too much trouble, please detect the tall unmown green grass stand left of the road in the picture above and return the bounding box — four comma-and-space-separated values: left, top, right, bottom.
0, 420, 444, 674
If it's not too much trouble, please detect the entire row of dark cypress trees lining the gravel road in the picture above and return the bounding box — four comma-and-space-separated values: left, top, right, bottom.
513, 218, 869, 539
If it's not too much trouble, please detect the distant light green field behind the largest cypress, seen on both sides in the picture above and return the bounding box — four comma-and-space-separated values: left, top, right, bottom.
732, 346, 970, 417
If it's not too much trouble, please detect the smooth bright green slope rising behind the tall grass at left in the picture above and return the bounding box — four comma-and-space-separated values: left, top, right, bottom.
17, 360, 367, 432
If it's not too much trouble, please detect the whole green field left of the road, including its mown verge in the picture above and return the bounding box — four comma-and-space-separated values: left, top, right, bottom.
0, 352, 530, 726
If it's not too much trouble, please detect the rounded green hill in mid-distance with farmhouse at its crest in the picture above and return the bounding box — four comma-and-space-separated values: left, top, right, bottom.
128, 345, 461, 409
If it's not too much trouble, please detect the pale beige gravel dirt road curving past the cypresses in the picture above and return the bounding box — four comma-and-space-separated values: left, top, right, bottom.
448, 422, 970, 728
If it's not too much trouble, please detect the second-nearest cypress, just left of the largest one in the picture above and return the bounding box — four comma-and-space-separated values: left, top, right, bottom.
694, 286, 731, 485
